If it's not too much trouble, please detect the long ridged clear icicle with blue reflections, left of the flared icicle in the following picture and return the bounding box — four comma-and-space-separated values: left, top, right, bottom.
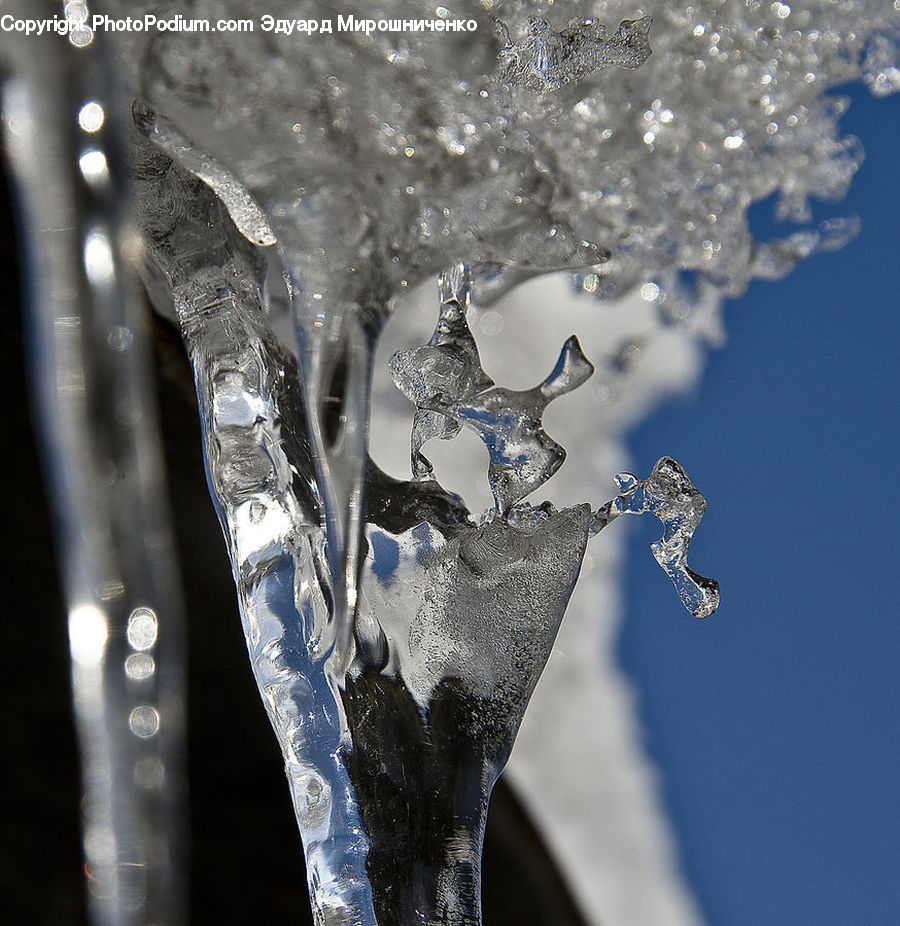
135, 140, 375, 924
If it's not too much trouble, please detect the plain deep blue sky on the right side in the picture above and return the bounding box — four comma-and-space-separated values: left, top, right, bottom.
620, 86, 900, 926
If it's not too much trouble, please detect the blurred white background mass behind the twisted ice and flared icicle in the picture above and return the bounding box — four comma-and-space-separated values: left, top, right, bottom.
372, 274, 727, 926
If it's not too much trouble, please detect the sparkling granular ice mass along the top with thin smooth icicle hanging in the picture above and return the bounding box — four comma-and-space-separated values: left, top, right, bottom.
112, 0, 897, 696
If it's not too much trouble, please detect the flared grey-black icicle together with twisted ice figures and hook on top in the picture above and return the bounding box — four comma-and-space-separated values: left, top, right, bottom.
358, 264, 718, 924
